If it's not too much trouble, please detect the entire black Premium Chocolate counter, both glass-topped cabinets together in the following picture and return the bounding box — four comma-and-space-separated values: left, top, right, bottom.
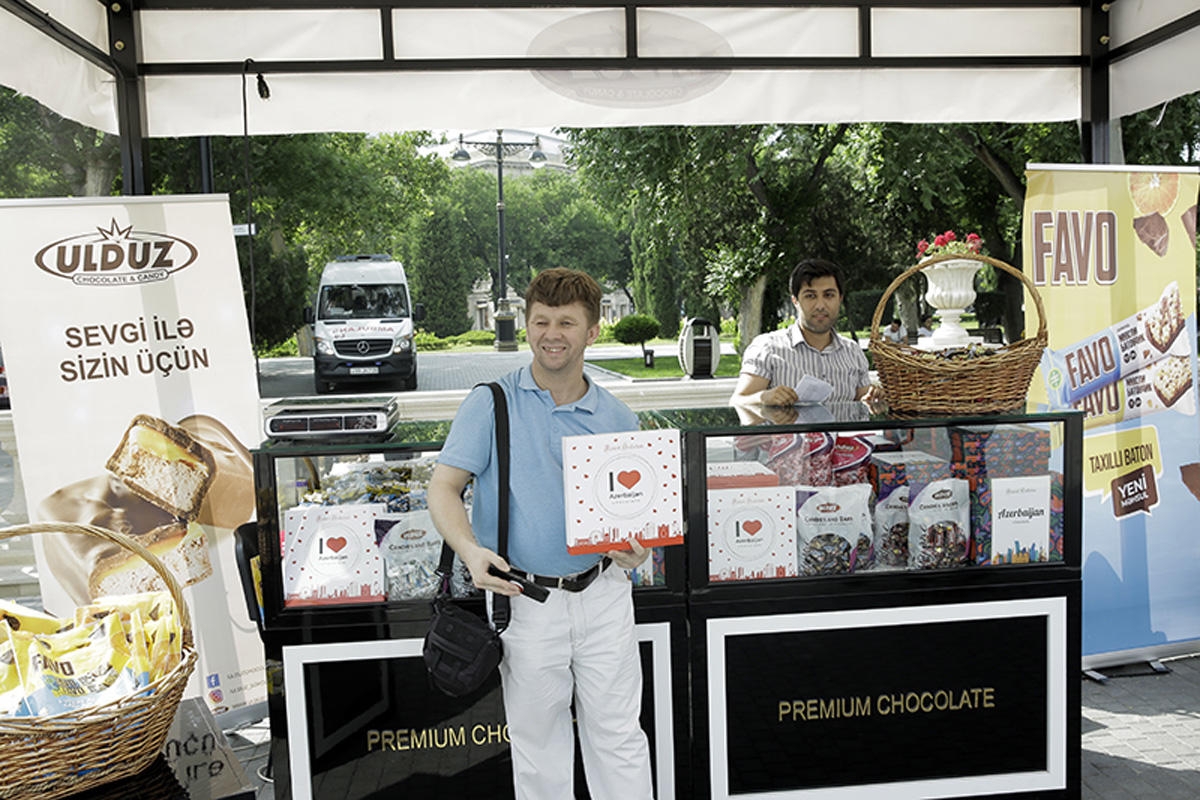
254, 404, 1081, 800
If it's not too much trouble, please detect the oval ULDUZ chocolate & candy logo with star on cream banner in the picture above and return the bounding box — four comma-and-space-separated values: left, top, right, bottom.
34, 219, 198, 287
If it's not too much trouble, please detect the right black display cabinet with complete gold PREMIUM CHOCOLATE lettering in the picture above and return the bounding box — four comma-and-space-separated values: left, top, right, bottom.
659, 404, 1082, 800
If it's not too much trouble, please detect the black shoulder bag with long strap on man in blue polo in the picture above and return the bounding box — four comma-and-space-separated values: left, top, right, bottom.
421, 383, 509, 697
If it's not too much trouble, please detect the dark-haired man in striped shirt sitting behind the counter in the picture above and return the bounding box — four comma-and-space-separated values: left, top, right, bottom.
730, 259, 880, 405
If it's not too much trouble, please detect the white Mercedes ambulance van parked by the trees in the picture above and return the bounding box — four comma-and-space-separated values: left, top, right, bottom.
305, 255, 425, 393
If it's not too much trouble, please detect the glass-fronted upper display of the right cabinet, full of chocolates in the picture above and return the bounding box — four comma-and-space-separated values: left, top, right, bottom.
700, 419, 1063, 583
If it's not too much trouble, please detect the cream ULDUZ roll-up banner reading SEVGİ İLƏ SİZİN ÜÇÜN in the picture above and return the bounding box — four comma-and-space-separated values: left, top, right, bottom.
0, 196, 266, 715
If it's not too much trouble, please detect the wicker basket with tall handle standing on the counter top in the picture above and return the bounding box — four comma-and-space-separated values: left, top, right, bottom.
870, 254, 1046, 414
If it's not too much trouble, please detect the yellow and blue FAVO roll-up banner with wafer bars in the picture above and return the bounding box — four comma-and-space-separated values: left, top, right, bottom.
1024, 164, 1200, 666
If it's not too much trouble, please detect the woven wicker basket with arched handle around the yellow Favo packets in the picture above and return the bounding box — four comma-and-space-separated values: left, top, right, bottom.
0, 523, 196, 800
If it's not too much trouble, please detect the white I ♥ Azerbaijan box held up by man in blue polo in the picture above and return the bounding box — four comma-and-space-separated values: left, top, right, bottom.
563, 428, 683, 555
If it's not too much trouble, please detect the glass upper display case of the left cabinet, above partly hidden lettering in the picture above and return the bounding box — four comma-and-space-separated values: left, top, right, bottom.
254, 412, 683, 628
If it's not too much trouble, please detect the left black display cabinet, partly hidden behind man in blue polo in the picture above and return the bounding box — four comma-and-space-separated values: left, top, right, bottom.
253, 422, 690, 800
